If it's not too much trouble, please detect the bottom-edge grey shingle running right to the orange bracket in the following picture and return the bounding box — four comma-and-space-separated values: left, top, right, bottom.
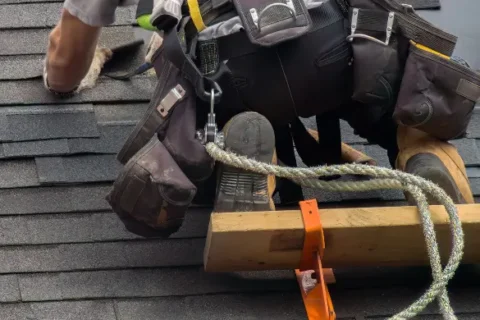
115, 292, 306, 320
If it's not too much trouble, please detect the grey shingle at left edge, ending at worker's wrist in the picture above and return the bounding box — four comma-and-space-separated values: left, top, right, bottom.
0, 55, 45, 80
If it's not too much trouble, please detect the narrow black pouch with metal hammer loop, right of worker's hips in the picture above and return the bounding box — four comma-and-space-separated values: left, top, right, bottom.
348, 8, 408, 117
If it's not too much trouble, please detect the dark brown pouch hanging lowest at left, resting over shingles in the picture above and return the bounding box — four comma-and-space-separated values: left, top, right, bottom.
107, 137, 196, 237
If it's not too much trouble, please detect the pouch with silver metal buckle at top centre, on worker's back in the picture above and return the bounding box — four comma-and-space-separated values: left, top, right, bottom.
233, 0, 312, 47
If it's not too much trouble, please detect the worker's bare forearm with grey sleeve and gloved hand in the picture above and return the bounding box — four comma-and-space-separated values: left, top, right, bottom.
44, 0, 138, 96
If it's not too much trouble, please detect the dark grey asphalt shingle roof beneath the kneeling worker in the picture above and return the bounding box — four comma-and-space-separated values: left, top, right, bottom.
0, 0, 480, 320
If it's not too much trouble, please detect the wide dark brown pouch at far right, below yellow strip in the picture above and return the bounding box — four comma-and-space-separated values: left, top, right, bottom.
393, 45, 480, 140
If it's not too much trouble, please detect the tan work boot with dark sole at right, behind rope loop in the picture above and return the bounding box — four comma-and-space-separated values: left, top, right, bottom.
395, 126, 475, 203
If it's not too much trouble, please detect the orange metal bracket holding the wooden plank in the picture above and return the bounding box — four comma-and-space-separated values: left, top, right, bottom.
295, 200, 336, 320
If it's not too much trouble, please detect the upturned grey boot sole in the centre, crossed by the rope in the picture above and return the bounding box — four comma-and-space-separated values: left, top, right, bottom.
214, 112, 276, 212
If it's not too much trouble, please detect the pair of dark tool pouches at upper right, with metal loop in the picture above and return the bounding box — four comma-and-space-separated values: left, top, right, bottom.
349, 0, 480, 140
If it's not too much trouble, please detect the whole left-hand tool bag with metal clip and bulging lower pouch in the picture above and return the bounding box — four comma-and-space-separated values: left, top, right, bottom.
107, 42, 214, 237
